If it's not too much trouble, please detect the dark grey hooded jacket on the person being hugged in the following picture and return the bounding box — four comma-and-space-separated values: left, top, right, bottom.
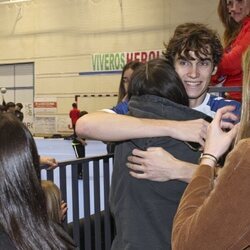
110, 95, 209, 250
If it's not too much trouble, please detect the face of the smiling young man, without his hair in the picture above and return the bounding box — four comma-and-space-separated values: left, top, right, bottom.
174, 51, 217, 107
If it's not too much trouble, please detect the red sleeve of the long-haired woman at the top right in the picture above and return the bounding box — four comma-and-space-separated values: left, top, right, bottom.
216, 20, 250, 76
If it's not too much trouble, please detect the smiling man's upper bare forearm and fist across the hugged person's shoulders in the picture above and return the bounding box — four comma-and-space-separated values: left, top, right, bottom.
76, 111, 208, 145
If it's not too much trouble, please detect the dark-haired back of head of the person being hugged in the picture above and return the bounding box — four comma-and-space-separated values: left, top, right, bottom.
128, 59, 188, 106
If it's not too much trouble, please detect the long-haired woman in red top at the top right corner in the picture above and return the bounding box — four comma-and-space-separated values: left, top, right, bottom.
213, 0, 250, 101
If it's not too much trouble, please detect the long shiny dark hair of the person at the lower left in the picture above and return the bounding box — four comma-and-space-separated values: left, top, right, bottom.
0, 113, 74, 250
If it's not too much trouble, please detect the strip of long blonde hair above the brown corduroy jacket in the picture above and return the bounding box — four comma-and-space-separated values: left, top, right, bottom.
236, 46, 250, 143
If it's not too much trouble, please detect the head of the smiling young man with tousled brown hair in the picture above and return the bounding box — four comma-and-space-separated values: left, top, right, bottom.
164, 23, 223, 108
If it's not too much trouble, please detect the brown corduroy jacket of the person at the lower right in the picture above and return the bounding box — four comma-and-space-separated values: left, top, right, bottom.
172, 139, 250, 250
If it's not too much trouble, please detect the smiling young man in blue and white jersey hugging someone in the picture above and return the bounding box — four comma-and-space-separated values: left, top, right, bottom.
76, 23, 240, 181
